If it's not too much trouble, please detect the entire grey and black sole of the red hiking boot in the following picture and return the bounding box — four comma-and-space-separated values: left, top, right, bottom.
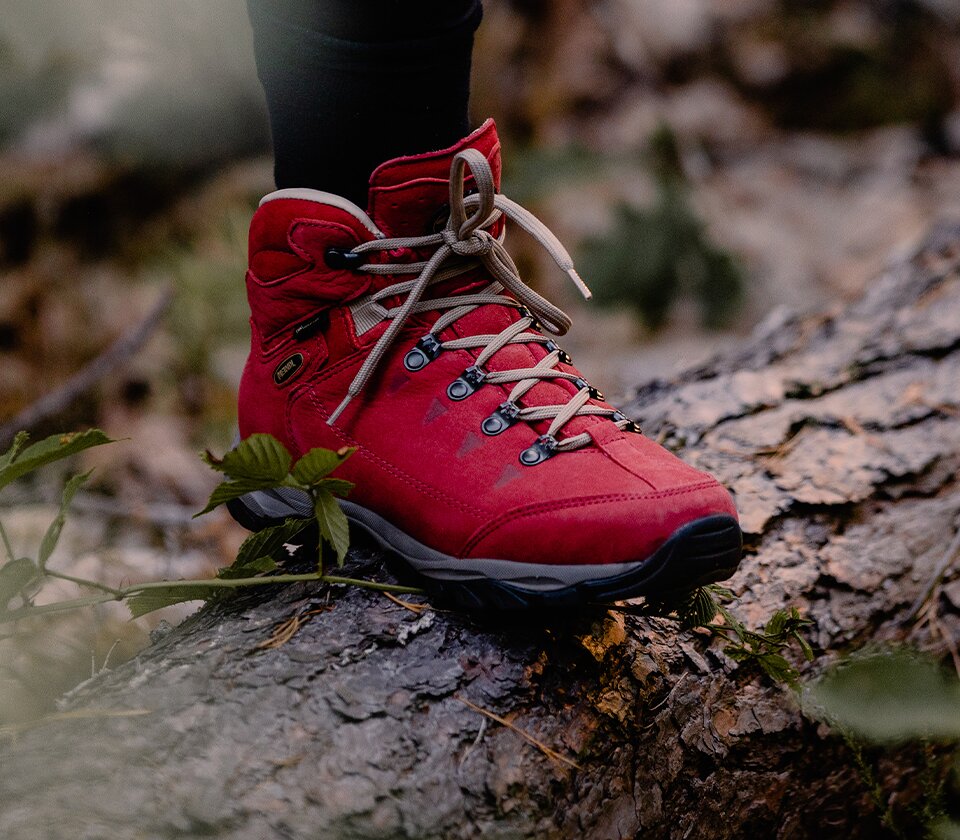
227, 490, 743, 610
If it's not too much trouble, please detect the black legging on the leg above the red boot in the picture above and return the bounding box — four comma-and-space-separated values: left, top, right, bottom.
247, 0, 482, 207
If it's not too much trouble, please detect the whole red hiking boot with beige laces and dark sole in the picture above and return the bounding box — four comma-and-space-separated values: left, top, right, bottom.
231, 121, 741, 608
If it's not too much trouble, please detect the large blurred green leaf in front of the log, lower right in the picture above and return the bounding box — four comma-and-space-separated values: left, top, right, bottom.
809, 650, 960, 742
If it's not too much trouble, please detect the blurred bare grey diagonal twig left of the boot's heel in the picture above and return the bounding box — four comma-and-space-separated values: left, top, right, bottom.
0, 287, 173, 446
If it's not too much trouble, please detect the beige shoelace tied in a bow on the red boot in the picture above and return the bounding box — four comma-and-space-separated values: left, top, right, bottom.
327, 149, 633, 463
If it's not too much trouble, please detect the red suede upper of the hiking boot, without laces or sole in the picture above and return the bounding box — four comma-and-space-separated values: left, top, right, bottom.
240, 121, 736, 565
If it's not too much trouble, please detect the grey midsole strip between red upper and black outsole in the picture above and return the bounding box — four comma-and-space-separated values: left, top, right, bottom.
233, 487, 642, 591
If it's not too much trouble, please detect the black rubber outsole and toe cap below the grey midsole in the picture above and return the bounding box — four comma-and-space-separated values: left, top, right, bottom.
227, 499, 743, 611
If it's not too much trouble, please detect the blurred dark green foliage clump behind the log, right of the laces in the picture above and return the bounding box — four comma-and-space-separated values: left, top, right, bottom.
581, 126, 744, 329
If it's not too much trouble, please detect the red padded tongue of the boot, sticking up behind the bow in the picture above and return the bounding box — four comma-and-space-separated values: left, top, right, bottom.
367, 120, 501, 237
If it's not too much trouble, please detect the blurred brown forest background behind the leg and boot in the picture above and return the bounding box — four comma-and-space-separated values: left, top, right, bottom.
0, 0, 960, 723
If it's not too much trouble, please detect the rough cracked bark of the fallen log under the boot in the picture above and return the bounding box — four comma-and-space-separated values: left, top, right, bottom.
0, 227, 960, 840
